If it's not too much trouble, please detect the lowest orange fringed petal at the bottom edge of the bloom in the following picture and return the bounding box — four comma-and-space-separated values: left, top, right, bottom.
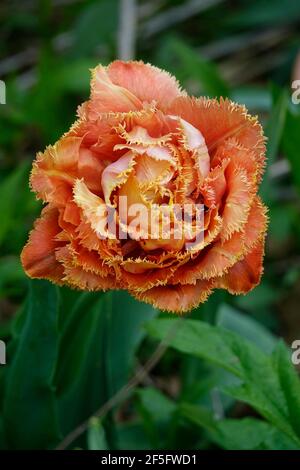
131, 281, 213, 313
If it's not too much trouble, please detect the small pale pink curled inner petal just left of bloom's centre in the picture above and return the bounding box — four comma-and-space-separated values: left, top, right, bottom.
101, 152, 135, 205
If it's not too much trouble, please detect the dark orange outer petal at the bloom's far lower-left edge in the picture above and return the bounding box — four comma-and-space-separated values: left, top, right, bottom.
21, 206, 63, 284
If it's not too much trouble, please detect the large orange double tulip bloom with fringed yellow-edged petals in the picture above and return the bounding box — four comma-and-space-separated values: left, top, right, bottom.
21, 61, 267, 312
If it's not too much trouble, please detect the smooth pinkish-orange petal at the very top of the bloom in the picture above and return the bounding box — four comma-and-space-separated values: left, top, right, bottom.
108, 60, 185, 109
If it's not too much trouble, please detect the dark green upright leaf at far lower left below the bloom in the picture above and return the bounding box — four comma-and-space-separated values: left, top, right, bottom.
4, 281, 59, 449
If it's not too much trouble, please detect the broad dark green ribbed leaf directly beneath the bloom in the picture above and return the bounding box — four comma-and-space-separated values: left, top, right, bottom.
56, 291, 156, 433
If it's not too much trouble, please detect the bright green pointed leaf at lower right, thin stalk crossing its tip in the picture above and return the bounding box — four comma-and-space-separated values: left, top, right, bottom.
148, 319, 300, 445
